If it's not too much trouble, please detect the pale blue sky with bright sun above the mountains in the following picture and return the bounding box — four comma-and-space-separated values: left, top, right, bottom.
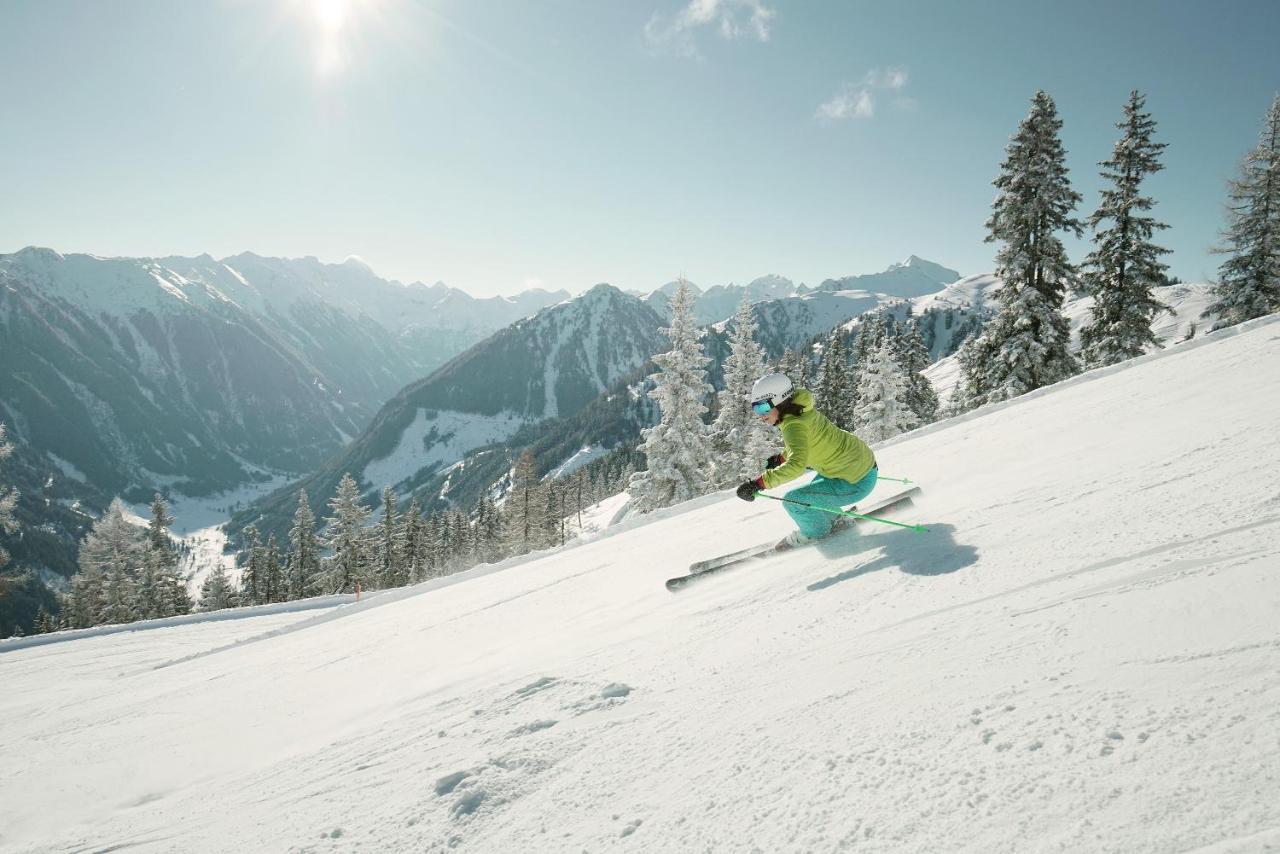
0, 0, 1280, 296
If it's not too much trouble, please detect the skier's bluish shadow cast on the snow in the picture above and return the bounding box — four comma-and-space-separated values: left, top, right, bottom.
808, 525, 978, 590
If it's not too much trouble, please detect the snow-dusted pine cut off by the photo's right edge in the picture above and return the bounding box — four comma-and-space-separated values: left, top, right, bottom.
1203, 95, 1280, 329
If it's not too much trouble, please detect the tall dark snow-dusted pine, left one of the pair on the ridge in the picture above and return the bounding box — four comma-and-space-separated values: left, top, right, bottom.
961, 91, 1083, 406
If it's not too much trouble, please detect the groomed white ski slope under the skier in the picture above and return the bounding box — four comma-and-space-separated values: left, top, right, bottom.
0, 318, 1280, 853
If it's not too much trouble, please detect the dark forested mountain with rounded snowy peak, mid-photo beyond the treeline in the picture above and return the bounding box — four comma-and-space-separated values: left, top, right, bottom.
233, 284, 664, 540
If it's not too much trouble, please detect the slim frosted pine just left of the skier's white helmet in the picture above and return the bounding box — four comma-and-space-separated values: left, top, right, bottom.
710, 296, 781, 489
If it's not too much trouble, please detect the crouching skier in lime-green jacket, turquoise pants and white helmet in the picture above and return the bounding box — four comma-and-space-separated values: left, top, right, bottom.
737, 374, 878, 548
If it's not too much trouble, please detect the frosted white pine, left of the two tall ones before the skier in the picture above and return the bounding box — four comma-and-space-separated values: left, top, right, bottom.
627, 278, 714, 512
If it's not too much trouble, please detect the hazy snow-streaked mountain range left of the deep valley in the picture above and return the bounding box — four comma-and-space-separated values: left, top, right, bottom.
0, 248, 566, 607
